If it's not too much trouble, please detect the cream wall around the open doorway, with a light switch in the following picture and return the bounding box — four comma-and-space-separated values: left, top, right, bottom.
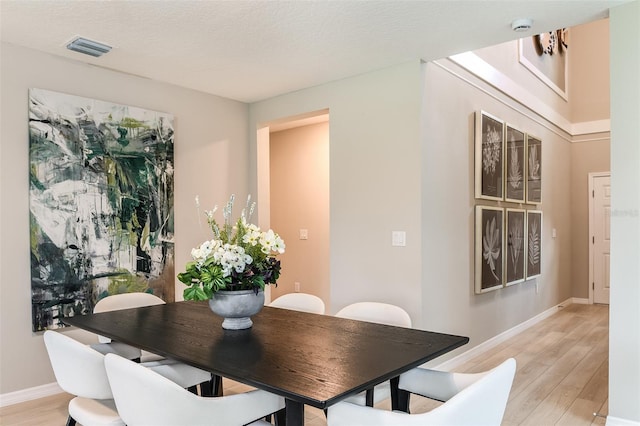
250, 61, 423, 327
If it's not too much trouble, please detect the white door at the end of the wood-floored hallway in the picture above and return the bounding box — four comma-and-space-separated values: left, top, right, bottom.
591, 176, 611, 304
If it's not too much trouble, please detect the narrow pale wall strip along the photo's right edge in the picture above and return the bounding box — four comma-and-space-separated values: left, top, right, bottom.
607, 1, 640, 425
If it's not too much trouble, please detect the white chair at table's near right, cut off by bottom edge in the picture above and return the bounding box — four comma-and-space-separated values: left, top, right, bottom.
327, 358, 516, 426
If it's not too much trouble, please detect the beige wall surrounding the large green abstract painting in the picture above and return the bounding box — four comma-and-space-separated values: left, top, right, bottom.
0, 43, 249, 395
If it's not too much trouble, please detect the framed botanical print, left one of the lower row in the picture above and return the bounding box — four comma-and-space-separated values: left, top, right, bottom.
475, 206, 504, 294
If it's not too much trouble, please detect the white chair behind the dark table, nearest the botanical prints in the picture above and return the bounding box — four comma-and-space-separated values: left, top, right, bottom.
335, 302, 412, 406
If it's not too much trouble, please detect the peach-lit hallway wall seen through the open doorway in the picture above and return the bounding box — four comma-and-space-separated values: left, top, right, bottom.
270, 122, 330, 310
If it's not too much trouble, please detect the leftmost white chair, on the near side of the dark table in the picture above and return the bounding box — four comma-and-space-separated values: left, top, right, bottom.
44, 330, 124, 426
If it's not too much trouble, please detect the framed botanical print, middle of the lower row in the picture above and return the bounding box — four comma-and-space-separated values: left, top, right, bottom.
504, 209, 526, 286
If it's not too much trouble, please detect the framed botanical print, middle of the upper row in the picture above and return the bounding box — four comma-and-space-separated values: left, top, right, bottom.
504, 124, 525, 203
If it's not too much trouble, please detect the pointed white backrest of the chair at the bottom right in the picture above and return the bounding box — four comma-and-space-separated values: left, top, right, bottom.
417, 358, 516, 426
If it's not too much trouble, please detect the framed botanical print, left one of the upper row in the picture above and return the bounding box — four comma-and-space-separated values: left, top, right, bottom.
475, 111, 504, 200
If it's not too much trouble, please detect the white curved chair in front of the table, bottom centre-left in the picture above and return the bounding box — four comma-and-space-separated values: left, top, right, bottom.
105, 354, 284, 426
